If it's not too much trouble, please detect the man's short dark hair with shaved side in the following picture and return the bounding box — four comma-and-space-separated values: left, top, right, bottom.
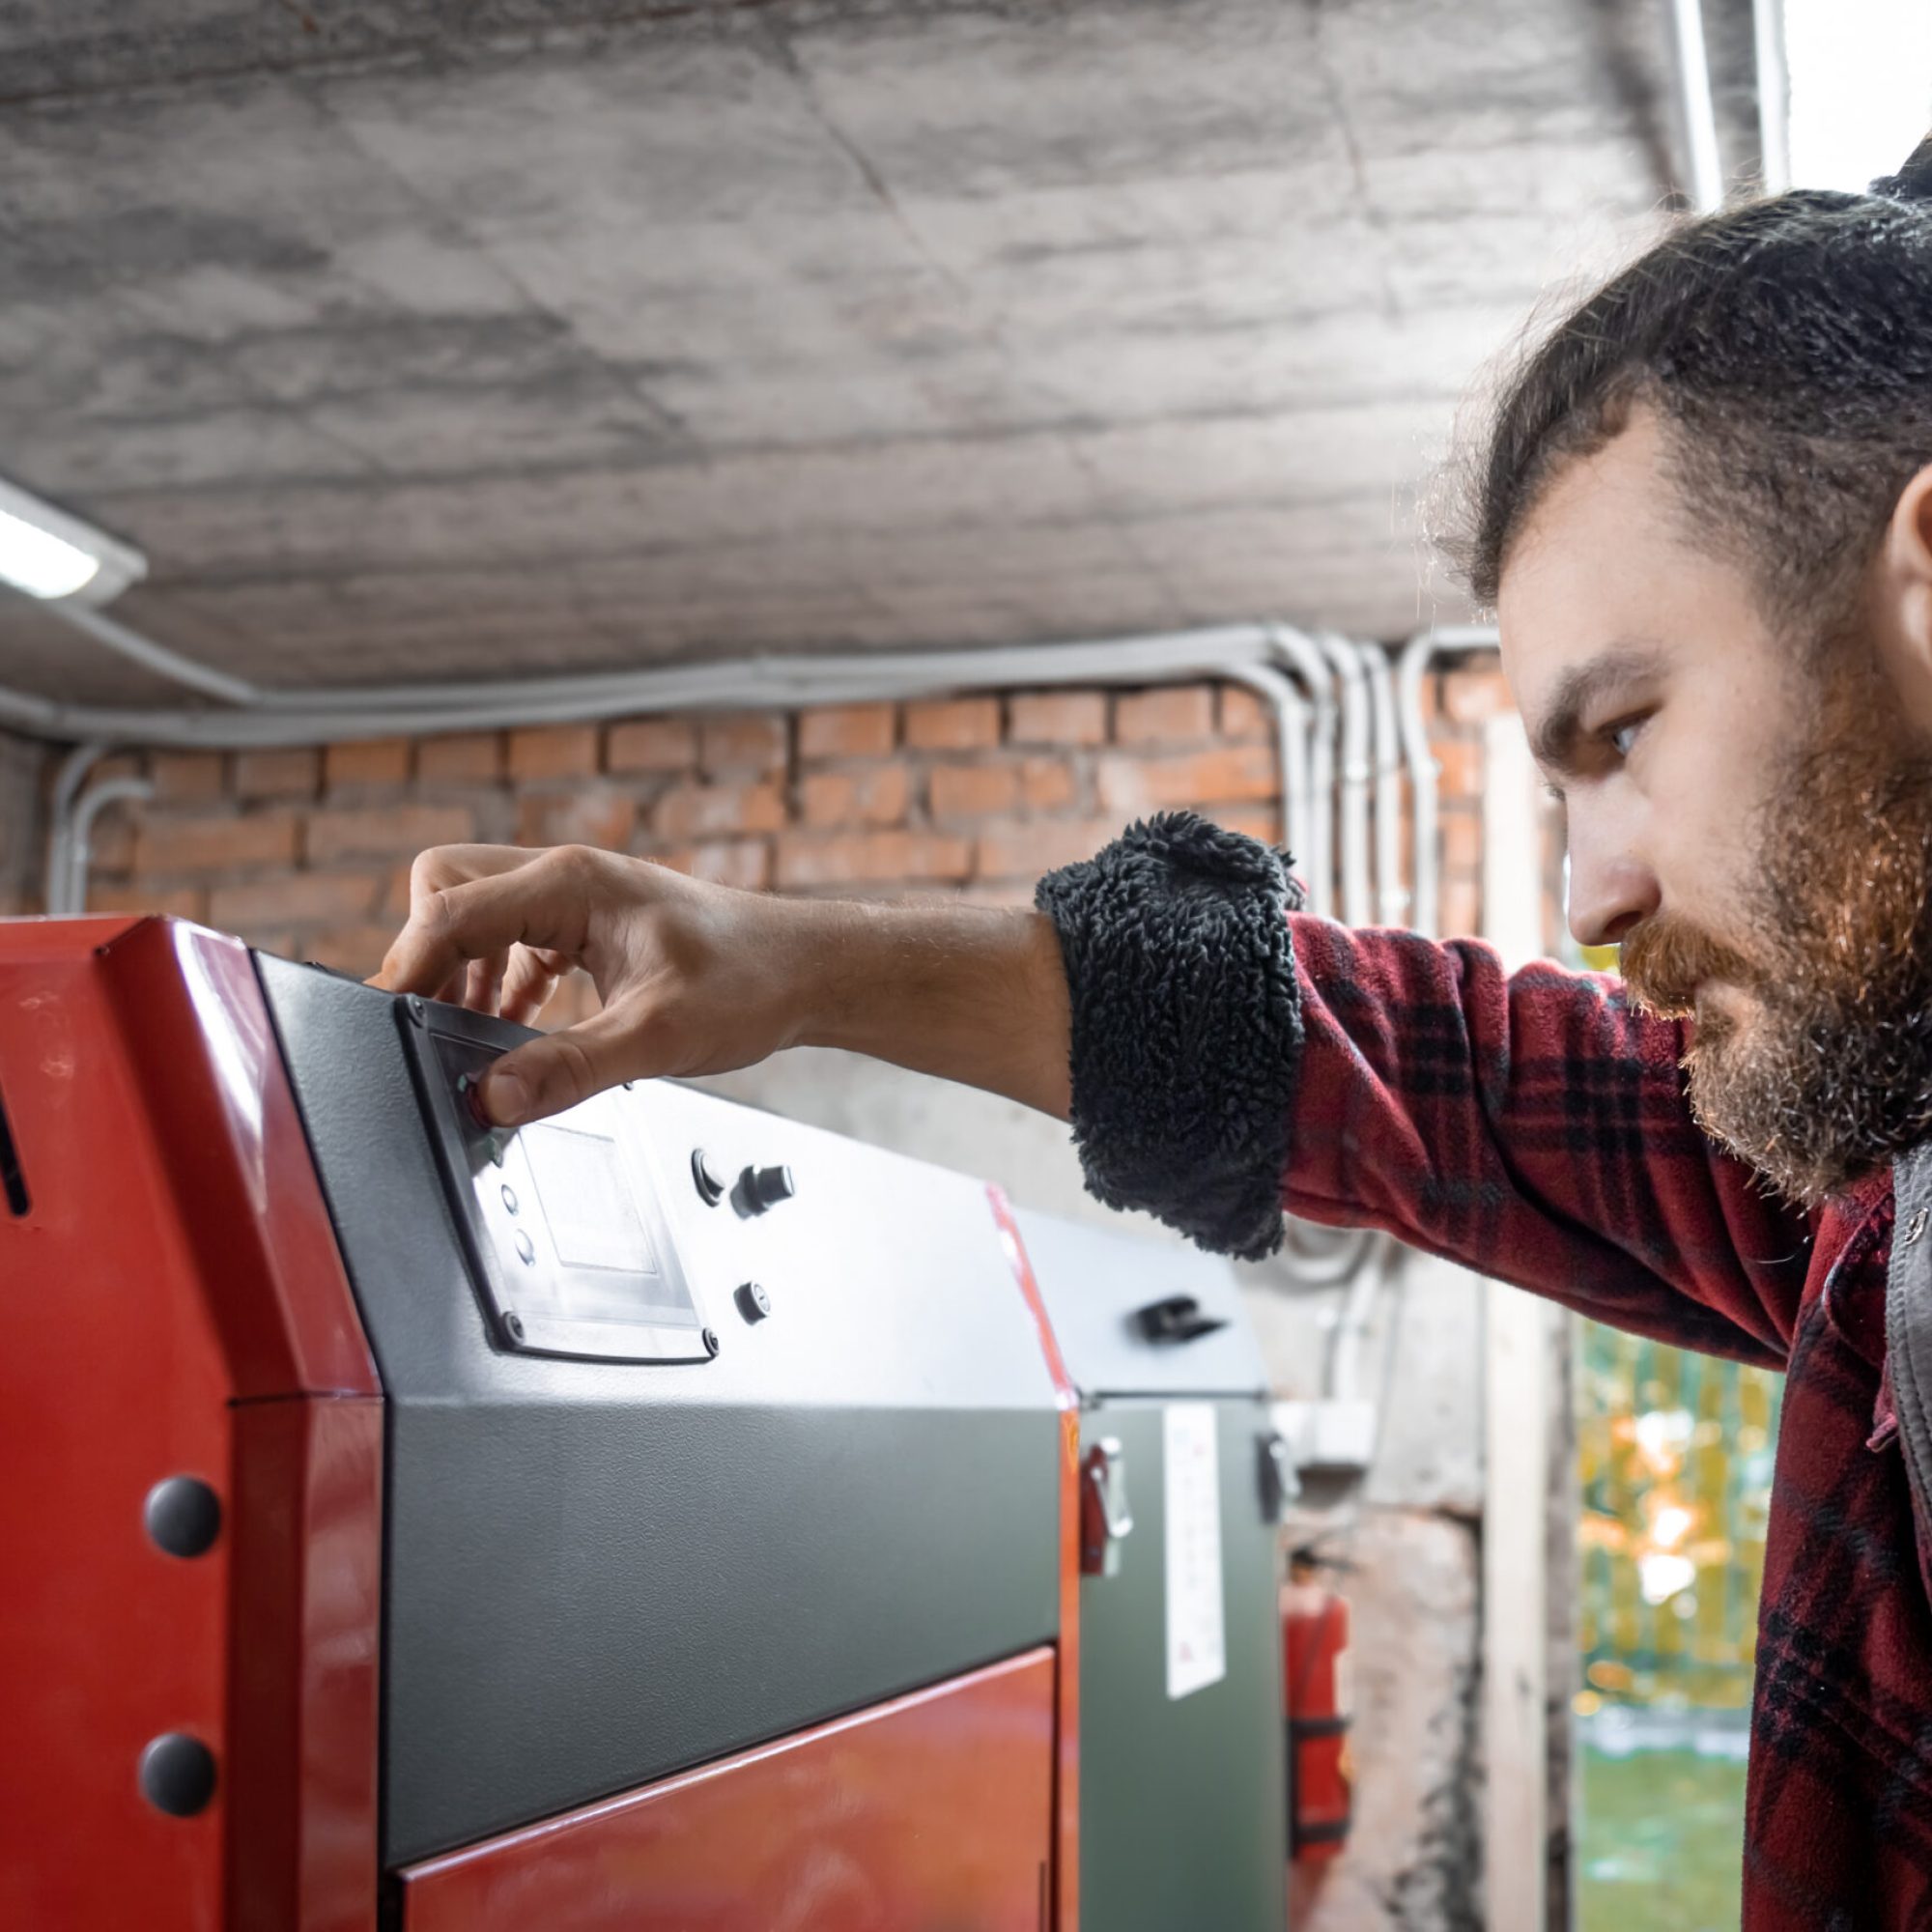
1453, 135, 1932, 620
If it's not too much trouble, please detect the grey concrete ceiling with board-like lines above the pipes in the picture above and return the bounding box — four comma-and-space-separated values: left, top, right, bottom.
0, 0, 1748, 699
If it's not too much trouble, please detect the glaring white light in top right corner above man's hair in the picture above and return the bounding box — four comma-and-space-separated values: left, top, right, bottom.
1783, 0, 1932, 193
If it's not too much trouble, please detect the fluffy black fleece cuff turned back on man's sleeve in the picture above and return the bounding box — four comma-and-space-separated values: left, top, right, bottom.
1034, 811, 1302, 1262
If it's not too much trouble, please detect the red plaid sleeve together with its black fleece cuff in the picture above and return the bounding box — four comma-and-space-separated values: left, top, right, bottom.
1037, 813, 1810, 1366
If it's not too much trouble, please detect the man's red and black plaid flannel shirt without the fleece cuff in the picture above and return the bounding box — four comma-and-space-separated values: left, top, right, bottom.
1283, 914, 1932, 1932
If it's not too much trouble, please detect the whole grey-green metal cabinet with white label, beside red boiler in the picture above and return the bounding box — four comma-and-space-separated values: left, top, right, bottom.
1020, 1215, 1287, 1932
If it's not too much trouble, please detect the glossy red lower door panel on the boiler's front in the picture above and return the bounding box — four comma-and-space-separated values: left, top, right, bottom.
400, 1650, 1055, 1932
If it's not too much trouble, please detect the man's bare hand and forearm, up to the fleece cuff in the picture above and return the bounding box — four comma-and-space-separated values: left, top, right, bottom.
375, 846, 1068, 1126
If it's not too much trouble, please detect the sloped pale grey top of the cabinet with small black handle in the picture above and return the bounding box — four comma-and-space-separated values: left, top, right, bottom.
1014, 1211, 1267, 1401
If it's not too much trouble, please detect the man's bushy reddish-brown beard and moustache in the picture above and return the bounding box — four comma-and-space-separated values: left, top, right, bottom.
1623, 670, 1932, 1208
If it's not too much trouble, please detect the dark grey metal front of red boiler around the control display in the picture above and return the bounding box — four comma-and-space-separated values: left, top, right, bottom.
261, 958, 1059, 1864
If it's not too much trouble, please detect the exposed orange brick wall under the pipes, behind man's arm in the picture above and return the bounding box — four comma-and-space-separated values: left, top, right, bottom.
48, 657, 1507, 972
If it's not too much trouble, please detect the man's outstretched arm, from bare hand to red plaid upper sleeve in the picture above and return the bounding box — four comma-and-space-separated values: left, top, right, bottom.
383, 813, 1808, 1360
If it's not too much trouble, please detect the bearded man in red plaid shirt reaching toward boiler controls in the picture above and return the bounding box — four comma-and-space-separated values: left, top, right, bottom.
384, 141, 1932, 1932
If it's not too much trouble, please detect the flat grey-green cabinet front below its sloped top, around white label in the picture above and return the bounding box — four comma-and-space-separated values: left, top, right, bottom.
1080, 1401, 1289, 1932
